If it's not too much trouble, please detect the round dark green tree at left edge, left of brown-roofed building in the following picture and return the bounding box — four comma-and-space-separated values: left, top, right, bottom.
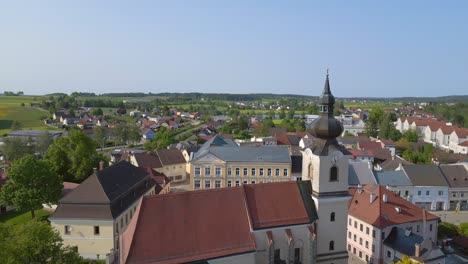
0, 155, 63, 219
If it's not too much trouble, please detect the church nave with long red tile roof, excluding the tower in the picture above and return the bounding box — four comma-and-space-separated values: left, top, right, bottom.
120, 182, 320, 264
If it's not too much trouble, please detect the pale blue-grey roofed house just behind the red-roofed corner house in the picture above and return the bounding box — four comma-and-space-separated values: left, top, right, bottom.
374, 170, 413, 199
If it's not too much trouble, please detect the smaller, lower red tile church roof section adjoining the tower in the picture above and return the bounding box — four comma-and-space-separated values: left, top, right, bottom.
244, 181, 310, 229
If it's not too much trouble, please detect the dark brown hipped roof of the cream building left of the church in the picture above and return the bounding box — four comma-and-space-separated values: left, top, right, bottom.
50, 161, 156, 219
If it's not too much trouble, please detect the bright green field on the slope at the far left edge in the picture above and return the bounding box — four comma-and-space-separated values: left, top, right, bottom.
0, 96, 49, 136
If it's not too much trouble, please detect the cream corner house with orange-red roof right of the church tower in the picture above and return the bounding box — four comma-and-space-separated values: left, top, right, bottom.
347, 184, 440, 263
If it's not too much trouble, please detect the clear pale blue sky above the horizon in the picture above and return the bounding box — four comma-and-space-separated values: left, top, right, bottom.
0, 0, 468, 97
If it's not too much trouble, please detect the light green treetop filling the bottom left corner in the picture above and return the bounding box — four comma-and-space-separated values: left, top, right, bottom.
0, 221, 85, 264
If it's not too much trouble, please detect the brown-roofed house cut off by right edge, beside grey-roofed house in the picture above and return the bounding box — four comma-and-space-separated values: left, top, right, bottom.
439, 164, 468, 210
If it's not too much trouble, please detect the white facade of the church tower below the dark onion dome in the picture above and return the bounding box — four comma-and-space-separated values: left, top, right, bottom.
302, 148, 351, 264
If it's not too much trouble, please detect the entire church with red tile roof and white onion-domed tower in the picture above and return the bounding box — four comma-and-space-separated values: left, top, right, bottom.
116, 73, 351, 264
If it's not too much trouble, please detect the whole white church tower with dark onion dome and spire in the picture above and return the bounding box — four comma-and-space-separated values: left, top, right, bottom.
302, 70, 351, 264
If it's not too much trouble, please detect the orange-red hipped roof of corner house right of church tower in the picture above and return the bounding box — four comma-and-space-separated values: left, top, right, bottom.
348, 184, 439, 228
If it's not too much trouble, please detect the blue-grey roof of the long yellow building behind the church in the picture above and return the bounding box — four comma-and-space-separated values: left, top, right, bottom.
197, 147, 291, 163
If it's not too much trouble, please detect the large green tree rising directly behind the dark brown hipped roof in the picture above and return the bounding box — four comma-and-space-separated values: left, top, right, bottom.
44, 130, 104, 182
